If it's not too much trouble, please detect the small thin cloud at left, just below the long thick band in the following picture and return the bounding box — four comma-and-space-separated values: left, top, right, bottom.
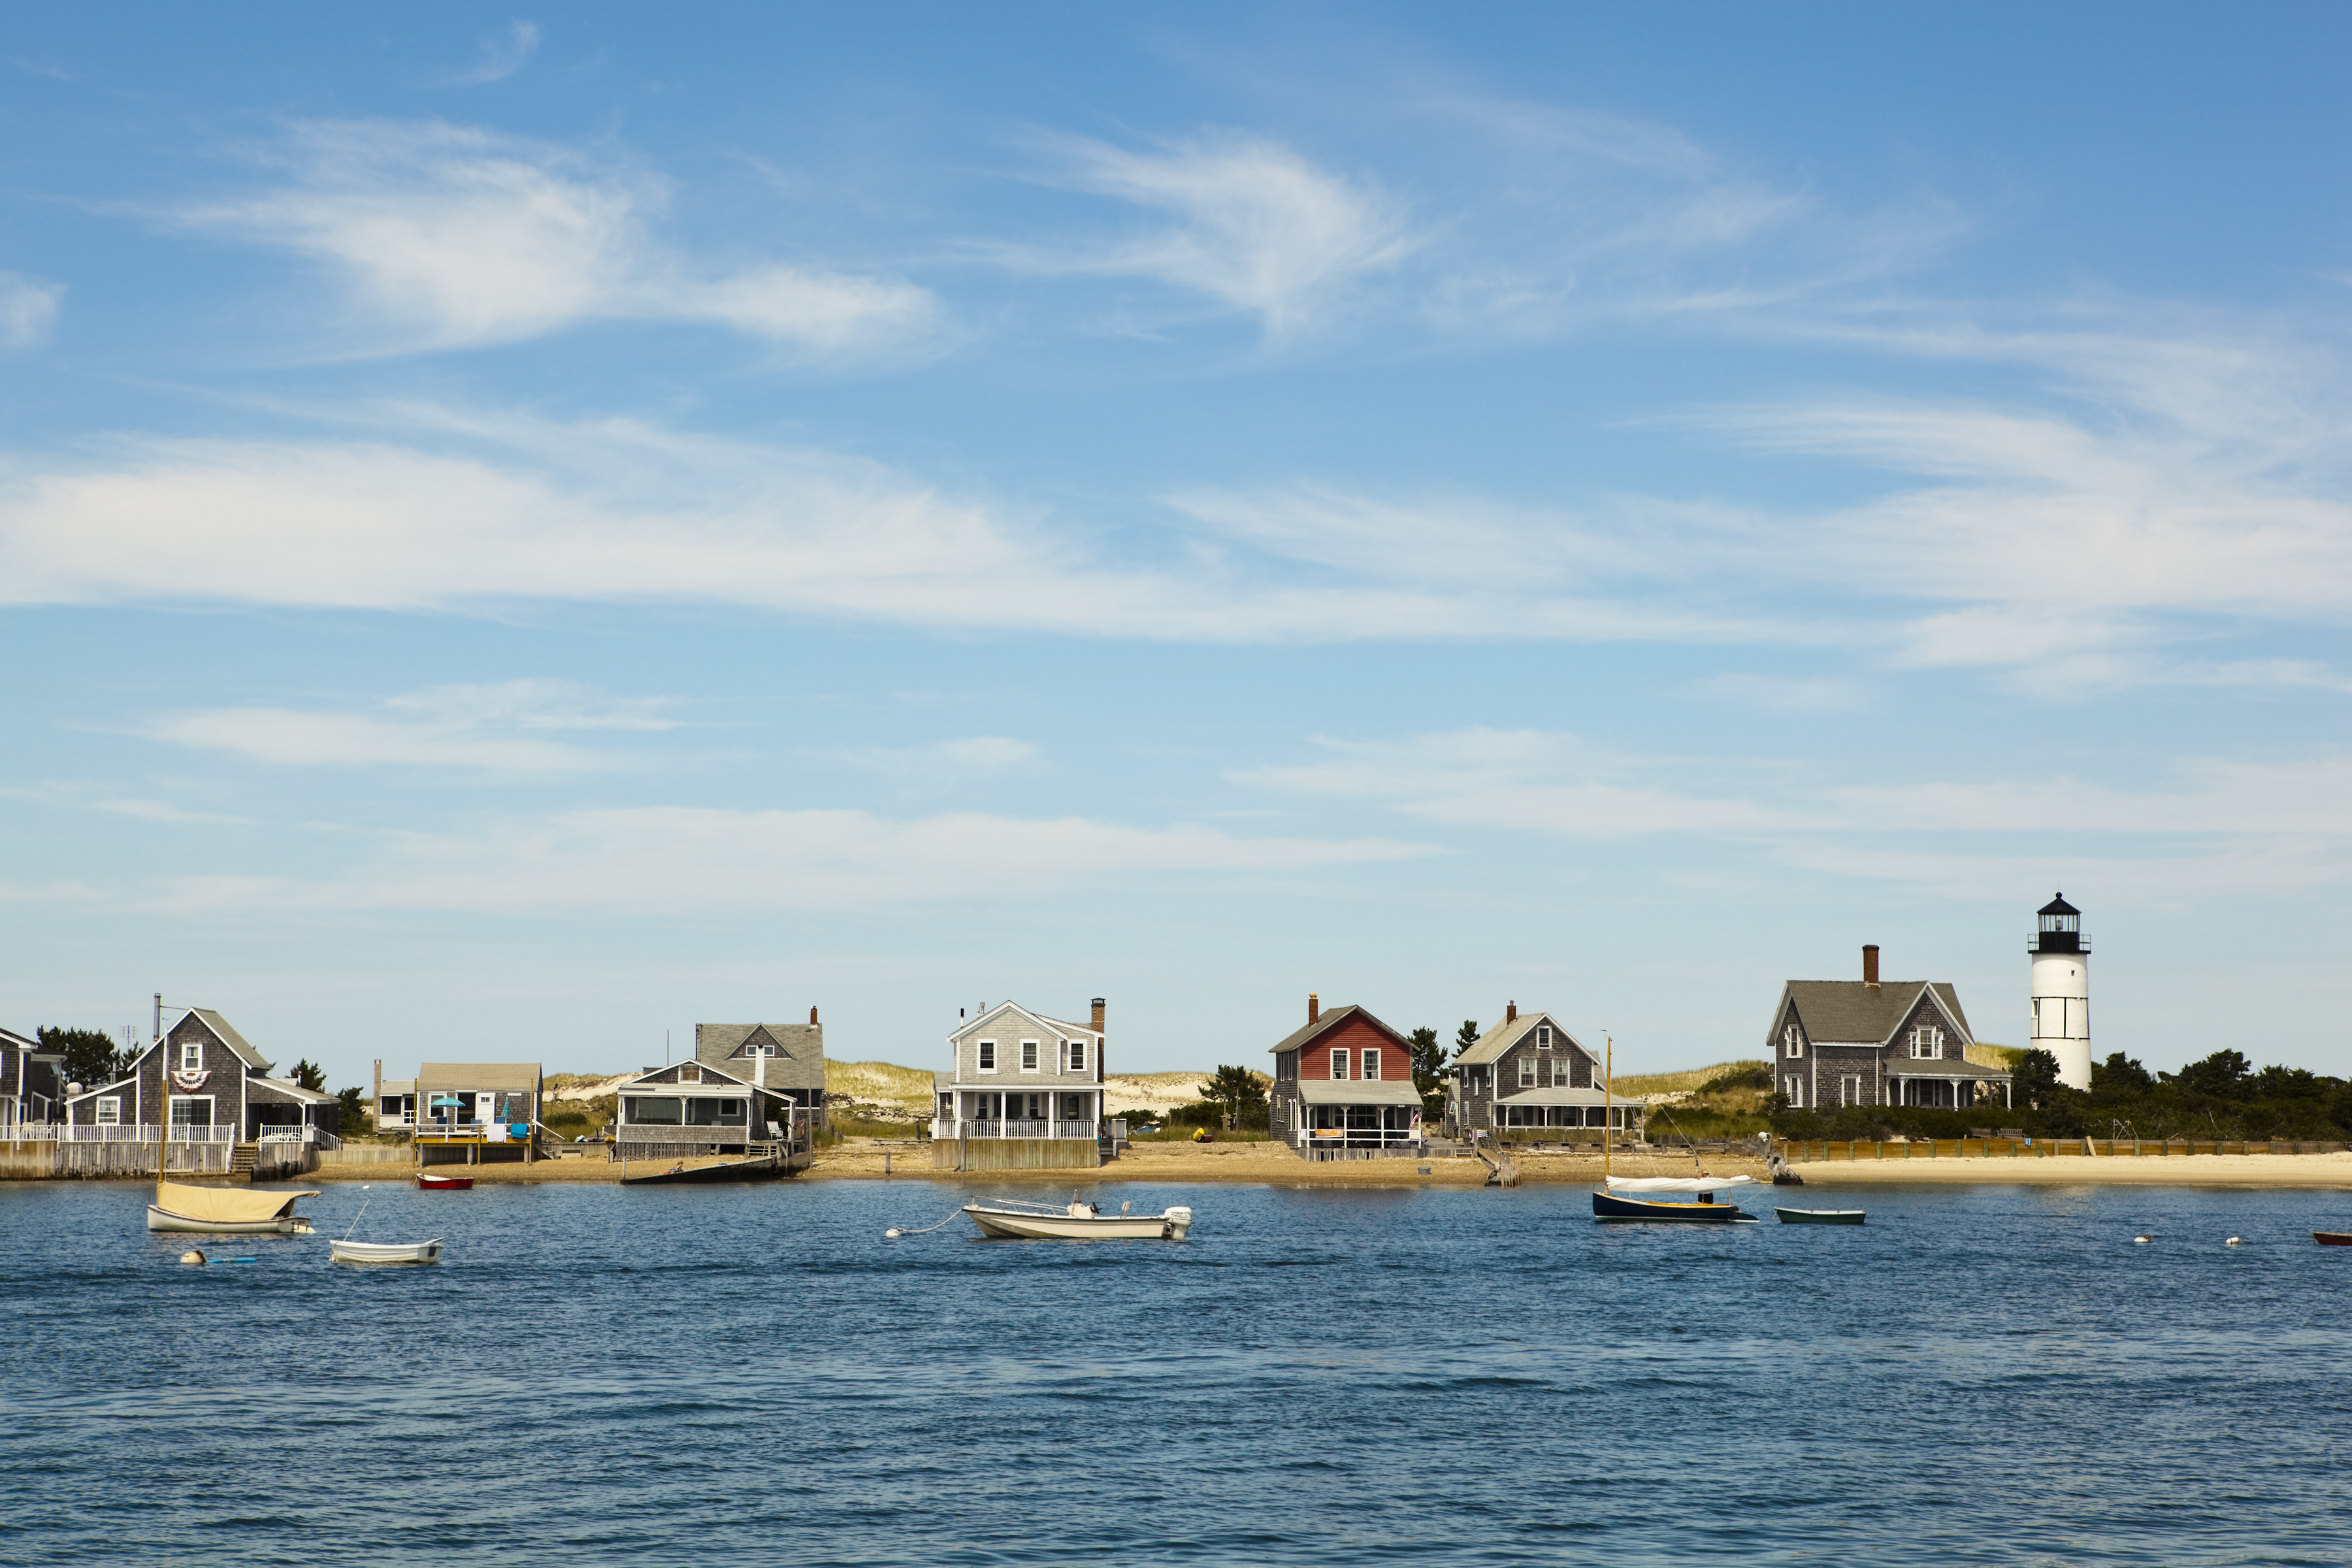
139, 679, 675, 774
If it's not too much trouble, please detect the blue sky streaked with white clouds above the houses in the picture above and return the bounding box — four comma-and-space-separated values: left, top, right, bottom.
0, 5, 2352, 1086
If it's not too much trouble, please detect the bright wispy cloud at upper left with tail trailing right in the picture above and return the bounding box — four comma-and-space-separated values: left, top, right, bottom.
176, 120, 941, 357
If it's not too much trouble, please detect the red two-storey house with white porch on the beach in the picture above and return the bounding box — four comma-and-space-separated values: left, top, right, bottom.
1267, 992, 1420, 1159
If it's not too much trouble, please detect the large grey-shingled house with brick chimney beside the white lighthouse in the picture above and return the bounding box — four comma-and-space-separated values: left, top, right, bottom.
1764, 943, 2011, 1109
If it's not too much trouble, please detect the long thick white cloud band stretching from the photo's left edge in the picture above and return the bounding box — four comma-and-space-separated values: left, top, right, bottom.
0, 406, 1804, 642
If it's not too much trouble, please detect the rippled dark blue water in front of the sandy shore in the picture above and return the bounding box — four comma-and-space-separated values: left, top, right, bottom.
0, 1180, 2352, 1568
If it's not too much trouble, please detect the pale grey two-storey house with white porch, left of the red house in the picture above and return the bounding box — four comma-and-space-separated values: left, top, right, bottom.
932, 997, 1105, 1171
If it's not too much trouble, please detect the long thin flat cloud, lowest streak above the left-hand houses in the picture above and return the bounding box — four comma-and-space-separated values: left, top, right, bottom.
161, 806, 1428, 915
